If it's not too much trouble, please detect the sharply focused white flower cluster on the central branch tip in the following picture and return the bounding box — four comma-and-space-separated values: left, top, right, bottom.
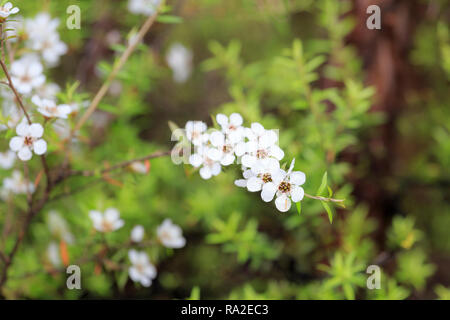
185, 113, 306, 212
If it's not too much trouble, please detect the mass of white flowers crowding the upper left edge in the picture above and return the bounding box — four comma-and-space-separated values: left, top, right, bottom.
0, 6, 80, 164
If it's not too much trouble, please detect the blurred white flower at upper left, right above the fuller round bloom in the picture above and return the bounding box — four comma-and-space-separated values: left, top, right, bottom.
29, 32, 67, 67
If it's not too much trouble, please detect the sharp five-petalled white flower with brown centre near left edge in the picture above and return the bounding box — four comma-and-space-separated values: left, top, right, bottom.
9, 121, 47, 161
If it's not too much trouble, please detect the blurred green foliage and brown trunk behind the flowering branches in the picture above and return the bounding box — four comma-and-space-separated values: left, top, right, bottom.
0, 0, 450, 299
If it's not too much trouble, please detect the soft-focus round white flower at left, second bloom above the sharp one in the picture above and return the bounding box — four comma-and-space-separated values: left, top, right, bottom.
11, 56, 45, 95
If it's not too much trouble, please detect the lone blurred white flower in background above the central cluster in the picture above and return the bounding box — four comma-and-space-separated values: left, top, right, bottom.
166, 43, 192, 83
